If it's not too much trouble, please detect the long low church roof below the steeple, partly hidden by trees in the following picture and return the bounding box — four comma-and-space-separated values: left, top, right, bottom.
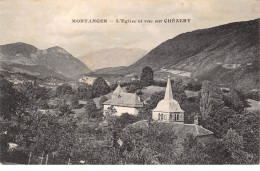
124, 120, 213, 139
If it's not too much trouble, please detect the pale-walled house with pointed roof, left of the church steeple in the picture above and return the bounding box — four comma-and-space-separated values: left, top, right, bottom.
103, 85, 143, 116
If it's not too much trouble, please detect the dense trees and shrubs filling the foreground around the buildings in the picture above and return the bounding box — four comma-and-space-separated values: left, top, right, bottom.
0, 68, 259, 164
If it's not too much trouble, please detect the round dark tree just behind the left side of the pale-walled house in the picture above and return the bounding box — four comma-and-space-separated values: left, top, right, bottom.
93, 77, 110, 97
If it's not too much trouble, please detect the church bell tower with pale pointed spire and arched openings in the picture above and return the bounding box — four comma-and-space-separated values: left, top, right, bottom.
152, 76, 184, 123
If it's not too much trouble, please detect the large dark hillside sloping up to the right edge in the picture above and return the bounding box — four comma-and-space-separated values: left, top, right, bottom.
121, 19, 260, 89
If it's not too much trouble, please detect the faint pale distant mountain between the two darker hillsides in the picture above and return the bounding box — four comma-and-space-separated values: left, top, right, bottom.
79, 48, 147, 70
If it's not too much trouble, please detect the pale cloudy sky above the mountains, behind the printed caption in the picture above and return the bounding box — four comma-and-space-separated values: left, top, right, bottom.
0, 0, 260, 57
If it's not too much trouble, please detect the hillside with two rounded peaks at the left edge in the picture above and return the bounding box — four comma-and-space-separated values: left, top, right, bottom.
0, 43, 90, 79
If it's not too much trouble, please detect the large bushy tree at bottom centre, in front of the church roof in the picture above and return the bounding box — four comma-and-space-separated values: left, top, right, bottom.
120, 122, 180, 164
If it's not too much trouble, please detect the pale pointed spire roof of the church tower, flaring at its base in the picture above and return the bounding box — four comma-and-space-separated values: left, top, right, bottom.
153, 77, 184, 112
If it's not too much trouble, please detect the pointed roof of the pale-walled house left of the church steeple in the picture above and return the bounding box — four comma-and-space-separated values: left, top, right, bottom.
103, 85, 143, 107
